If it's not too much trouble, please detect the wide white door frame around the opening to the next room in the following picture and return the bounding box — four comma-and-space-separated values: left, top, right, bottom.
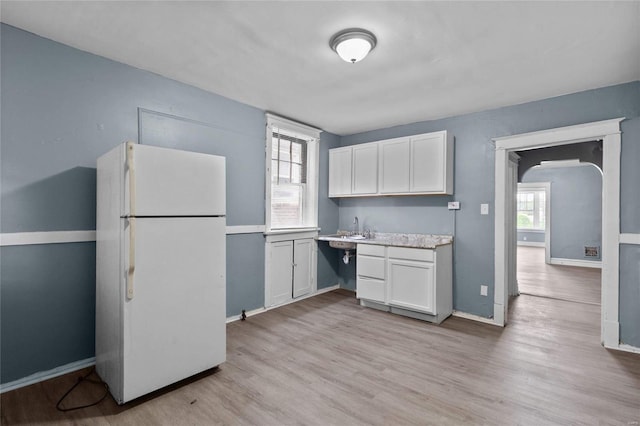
493, 117, 624, 349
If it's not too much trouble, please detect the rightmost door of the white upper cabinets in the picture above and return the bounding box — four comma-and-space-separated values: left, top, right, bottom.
410, 133, 446, 193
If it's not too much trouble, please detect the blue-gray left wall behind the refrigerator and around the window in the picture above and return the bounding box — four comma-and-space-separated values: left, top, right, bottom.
0, 24, 340, 383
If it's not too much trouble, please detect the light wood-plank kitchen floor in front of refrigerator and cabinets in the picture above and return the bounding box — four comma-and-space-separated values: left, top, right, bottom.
1, 290, 640, 426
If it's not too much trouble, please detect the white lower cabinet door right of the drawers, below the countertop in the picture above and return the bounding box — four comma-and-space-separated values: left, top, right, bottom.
388, 259, 436, 315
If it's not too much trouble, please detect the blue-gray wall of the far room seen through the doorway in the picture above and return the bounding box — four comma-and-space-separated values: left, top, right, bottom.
518, 165, 602, 261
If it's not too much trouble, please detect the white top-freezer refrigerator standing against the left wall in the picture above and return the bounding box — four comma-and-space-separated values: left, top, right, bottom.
96, 142, 226, 404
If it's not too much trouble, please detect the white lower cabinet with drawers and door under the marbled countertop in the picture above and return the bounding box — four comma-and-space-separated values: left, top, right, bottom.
356, 244, 453, 323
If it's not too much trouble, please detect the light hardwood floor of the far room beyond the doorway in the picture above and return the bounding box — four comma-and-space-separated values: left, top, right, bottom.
518, 246, 601, 305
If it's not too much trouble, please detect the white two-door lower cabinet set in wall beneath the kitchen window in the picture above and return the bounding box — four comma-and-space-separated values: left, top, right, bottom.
265, 238, 316, 307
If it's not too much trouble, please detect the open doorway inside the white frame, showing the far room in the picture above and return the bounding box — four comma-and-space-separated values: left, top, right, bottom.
516, 146, 603, 306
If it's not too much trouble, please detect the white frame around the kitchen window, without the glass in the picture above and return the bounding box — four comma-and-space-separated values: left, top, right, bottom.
265, 113, 321, 234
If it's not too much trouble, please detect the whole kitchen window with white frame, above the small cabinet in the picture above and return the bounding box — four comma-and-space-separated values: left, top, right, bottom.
265, 114, 320, 230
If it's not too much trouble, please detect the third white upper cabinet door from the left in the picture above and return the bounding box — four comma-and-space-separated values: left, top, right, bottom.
380, 138, 410, 194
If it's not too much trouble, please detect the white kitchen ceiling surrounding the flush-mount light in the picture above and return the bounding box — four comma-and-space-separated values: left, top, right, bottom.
0, 0, 640, 135
